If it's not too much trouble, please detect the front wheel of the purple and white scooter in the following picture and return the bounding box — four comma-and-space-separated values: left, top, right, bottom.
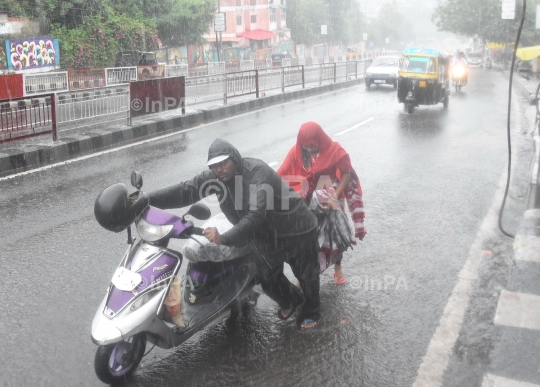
94, 333, 146, 384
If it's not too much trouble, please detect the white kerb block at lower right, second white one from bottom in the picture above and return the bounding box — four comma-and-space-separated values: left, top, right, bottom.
495, 290, 540, 330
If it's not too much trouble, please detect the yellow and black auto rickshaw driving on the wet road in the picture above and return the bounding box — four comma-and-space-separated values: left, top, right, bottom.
398, 48, 450, 114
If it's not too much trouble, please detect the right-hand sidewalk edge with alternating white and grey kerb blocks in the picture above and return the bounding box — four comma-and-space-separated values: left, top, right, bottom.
482, 76, 540, 387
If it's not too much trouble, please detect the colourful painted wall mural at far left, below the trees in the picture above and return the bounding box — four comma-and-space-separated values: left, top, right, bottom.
8, 36, 58, 71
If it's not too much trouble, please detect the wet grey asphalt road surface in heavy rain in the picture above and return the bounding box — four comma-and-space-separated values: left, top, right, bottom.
0, 69, 521, 387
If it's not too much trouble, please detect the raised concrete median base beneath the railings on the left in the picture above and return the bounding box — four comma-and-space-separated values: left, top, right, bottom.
0, 76, 364, 177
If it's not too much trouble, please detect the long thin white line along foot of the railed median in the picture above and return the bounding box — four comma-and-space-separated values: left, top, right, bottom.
0, 85, 368, 182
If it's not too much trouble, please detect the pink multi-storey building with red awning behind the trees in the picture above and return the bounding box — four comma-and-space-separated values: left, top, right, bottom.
204, 0, 291, 52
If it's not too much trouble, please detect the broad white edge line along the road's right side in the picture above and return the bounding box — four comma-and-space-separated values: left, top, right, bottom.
413, 91, 521, 387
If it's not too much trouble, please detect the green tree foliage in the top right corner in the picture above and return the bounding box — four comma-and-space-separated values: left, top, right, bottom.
432, 0, 540, 45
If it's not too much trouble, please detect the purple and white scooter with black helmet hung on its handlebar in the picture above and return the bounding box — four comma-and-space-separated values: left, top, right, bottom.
92, 172, 259, 384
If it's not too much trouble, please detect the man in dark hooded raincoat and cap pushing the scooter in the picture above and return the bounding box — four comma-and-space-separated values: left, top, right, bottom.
149, 139, 320, 329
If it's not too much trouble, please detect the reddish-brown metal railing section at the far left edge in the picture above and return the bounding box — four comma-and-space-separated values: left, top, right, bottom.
0, 94, 57, 144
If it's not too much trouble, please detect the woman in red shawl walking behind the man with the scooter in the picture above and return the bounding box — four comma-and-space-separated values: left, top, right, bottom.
277, 122, 366, 284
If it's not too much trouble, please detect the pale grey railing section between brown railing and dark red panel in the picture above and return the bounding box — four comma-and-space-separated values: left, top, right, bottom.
56, 85, 130, 124
